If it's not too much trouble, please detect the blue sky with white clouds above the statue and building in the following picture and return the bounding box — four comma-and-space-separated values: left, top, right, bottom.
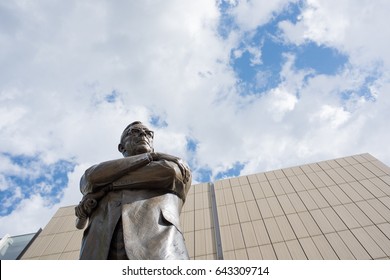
0, 0, 390, 237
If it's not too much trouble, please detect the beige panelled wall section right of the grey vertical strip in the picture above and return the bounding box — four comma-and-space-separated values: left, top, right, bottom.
215, 154, 390, 260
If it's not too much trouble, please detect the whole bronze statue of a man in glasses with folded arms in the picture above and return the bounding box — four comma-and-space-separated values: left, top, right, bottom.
76, 121, 191, 260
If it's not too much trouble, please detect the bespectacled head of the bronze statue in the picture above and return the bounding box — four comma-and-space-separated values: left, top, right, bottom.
118, 121, 154, 157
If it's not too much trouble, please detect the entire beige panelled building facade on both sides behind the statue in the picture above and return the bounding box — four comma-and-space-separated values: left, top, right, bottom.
22, 154, 390, 260
